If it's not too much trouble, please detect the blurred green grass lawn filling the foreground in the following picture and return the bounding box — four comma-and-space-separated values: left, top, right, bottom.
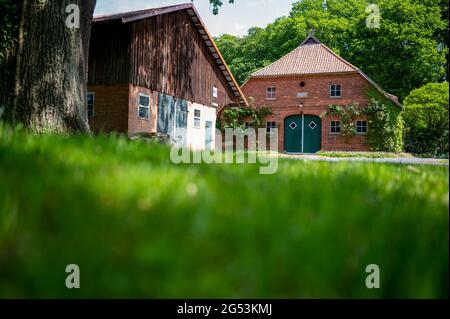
0, 129, 449, 298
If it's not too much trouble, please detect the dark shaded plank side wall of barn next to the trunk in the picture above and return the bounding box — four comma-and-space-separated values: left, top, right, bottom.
88, 22, 131, 85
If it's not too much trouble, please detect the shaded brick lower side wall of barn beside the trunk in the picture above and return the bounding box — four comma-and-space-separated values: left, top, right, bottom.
88, 84, 128, 133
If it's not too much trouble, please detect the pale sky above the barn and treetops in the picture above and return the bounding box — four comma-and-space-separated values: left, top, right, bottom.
94, 0, 298, 36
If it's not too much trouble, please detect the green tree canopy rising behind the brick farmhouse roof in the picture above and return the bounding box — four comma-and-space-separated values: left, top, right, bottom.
217, 0, 448, 100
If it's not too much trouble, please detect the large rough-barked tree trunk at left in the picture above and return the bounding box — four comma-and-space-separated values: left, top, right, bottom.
3, 0, 96, 132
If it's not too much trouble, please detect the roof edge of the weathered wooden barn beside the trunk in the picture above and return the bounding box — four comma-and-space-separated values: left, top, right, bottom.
93, 3, 248, 105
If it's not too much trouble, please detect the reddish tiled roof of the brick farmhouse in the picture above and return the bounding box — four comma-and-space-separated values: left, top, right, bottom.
250, 34, 402, 107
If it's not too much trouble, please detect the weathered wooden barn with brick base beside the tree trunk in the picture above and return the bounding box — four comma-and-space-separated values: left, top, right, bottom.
87, 3, 247, 149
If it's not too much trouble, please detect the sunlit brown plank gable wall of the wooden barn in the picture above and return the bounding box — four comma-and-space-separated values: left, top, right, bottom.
130, 11, 235, 107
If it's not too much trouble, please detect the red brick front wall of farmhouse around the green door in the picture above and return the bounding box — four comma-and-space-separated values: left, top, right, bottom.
242, 73, 370, 151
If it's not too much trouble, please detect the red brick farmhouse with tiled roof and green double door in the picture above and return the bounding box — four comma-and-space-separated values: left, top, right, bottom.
242, 34, 402, 153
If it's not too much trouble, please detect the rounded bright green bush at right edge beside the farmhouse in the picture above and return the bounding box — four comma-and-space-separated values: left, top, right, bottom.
403, 82, 449, 157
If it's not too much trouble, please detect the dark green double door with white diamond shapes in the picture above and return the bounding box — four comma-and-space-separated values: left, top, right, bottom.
284, 115, 322, 153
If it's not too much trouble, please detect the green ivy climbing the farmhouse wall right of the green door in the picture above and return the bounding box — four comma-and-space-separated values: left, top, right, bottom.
326, 91, 403, 152
